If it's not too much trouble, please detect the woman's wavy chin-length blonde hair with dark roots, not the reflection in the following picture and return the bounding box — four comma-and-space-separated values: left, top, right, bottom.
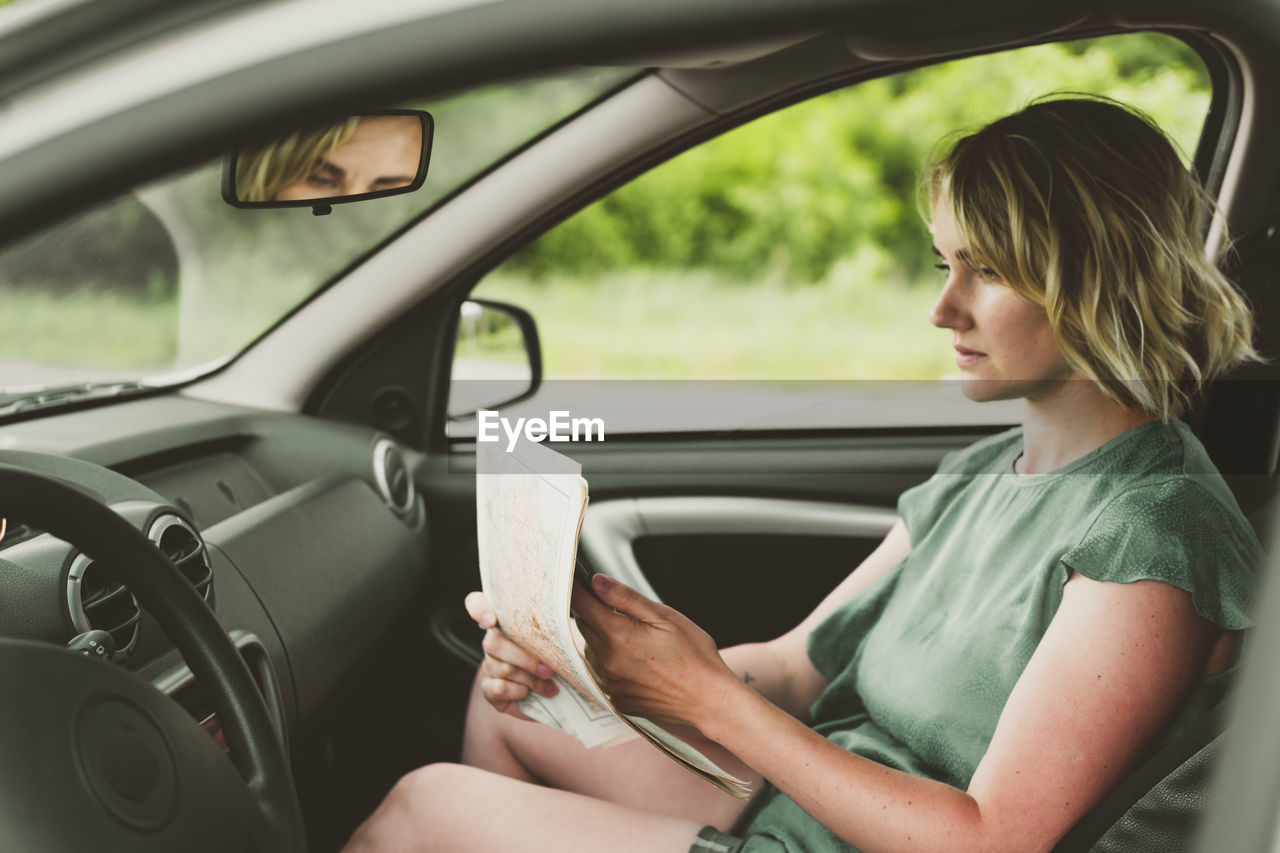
927, 96, 1258, 420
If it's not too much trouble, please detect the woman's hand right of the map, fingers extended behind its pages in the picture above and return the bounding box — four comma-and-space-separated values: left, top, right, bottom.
573, 575, 741, 727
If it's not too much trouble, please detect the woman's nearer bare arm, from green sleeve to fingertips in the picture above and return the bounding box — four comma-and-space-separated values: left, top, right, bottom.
575, 563, 1216, 853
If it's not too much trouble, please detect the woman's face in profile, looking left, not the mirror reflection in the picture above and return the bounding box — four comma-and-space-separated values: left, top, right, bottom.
929, 205, 1073, 401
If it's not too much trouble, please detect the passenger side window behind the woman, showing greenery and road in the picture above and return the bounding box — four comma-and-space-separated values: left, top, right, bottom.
449, 33, 1211, 435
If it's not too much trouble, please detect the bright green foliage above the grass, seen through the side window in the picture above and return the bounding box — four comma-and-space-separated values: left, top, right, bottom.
507, 33, 1210, 283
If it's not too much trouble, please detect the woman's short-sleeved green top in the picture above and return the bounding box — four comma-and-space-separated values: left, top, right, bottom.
744, 421, 1262, 853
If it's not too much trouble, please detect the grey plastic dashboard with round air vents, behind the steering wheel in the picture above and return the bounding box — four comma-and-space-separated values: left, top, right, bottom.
0, 396, 430, 739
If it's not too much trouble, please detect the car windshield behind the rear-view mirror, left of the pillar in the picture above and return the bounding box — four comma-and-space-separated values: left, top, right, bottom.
0, 68, 637, 403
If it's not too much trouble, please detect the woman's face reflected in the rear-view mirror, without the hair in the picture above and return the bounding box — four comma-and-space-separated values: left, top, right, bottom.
275, 115, 422, 200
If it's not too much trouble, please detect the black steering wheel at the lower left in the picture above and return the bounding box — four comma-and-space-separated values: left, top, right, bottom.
0, 465, 306, 853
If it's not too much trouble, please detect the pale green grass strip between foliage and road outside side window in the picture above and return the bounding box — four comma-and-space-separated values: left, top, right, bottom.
472, 265, 955, 379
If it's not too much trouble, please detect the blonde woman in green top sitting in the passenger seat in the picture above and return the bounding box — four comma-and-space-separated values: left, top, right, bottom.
349, 99, 1261, 853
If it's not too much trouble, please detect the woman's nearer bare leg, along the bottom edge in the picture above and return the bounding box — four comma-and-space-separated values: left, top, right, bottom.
343, 765, 705, 853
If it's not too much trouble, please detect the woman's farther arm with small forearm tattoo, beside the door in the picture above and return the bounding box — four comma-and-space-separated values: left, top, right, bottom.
721, 521, 911, 720
